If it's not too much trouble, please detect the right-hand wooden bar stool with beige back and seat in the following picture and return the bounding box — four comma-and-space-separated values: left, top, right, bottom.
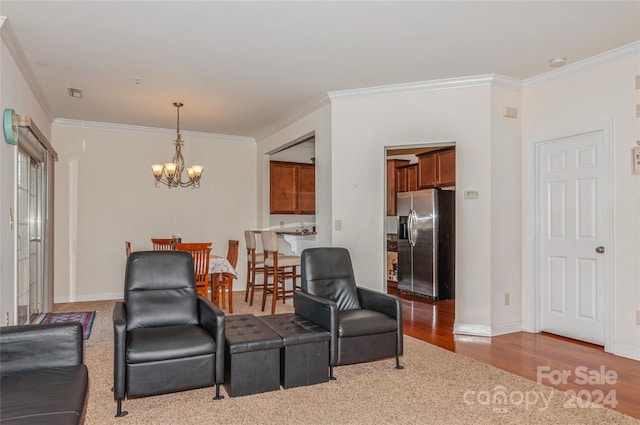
260, 231, 300, 314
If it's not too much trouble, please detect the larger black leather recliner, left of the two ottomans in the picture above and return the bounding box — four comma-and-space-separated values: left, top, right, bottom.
113, 251, 225, 416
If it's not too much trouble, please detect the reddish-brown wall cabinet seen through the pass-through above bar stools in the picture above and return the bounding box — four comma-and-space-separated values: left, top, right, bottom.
269, 161, 316, 214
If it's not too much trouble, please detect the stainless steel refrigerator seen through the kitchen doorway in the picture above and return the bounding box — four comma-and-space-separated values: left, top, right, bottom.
397, 189, 455, 300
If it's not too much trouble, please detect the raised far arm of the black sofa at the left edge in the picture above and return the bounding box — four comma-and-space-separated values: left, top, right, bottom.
0, 322, 84, 374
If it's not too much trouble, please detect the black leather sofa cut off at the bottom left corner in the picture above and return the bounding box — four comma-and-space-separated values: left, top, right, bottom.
0, 323, 89, 425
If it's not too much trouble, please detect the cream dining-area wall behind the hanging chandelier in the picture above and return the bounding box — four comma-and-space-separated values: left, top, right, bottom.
53, 121, 257, 302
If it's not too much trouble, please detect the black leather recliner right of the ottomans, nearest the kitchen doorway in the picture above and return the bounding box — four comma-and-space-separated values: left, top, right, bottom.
295, 247, 403, 379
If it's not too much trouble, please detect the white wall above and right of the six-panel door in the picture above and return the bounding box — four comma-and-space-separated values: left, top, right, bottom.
523, 43, 640, 359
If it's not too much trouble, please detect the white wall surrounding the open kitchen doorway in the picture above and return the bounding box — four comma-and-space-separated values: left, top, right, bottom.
332, 77, 519, 327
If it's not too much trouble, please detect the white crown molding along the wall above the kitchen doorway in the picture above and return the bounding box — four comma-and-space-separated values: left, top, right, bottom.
328, 74, 522, 102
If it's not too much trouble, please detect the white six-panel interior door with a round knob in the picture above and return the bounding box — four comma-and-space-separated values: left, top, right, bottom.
537, 131, 607, 345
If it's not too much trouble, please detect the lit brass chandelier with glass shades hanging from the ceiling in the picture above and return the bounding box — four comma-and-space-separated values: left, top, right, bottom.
151, 102, 203, 189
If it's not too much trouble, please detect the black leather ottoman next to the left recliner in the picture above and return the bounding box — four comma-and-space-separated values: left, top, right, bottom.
224, 314, 282, 397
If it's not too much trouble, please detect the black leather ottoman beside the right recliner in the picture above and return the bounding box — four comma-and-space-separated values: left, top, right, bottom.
259, 313, 329, 388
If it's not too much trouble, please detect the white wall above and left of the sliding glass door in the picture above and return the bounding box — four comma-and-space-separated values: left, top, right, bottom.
0, 33, 51, 325
